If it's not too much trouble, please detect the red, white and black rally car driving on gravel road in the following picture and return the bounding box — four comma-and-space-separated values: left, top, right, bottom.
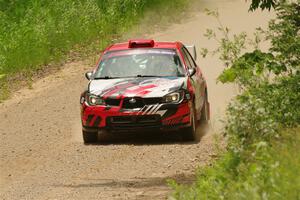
80, 40, 209, 143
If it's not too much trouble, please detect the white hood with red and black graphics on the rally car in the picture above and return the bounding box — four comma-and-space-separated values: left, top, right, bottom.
89, 77, 187, 98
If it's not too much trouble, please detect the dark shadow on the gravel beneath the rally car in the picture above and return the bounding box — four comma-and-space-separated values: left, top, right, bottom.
89, 123, 209, 145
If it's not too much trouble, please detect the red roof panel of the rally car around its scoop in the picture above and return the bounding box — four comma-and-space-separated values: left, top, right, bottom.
105, 39, 182, 51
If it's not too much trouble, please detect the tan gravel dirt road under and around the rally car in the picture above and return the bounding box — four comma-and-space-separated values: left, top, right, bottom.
0, 0, 269, 199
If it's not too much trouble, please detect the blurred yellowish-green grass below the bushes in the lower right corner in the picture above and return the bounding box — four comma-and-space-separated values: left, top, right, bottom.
169, 128, 300, 200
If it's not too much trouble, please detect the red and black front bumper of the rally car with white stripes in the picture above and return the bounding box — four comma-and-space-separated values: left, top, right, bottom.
81, 100, 192, 131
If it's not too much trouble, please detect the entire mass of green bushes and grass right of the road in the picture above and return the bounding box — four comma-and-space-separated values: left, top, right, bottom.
169, 0, 300, 200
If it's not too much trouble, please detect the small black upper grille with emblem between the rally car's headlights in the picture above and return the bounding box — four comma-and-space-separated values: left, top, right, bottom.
122, 97, 161, 109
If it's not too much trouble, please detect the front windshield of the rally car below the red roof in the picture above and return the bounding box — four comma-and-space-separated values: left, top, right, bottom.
94, 49, 185, 79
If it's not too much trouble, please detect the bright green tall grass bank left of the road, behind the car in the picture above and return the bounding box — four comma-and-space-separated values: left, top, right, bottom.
0, 0, 190, 102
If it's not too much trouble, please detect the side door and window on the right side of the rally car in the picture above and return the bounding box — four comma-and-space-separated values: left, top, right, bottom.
182, 46, 205, 116
